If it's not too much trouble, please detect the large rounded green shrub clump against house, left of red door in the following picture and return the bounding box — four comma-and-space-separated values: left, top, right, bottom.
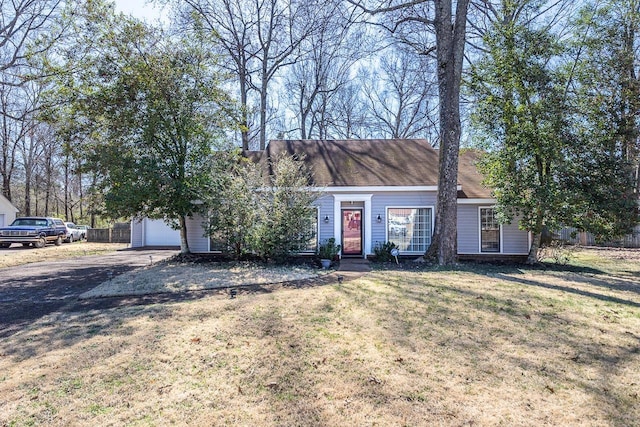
207, 155, 321, 261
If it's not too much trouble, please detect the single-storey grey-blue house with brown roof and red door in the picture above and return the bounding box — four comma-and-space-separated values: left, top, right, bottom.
131, 139, 531, 258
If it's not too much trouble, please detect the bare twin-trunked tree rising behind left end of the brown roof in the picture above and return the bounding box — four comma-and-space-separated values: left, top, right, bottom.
180, 0, 315, 150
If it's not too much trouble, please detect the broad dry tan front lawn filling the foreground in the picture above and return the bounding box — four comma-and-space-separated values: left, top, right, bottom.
0, 250, 640, 426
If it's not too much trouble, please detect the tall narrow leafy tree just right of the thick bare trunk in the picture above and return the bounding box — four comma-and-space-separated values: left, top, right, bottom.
470, 0, 572, 262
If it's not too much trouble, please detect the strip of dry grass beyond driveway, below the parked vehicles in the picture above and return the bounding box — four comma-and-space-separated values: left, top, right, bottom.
0, 241, 129, 268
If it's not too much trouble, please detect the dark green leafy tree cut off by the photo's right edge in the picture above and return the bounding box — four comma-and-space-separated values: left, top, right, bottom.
572, 0, 640, 240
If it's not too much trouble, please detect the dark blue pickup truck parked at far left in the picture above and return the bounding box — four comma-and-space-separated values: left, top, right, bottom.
0, 217, 67, 248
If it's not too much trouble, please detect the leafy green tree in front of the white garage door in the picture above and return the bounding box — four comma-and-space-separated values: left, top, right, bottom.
48, 6, 233, 252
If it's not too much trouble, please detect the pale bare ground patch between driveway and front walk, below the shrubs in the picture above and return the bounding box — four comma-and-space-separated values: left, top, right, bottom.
80, 263, 327, 299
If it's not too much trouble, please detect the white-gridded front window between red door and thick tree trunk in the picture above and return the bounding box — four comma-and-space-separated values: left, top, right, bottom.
387, 208, 432, 252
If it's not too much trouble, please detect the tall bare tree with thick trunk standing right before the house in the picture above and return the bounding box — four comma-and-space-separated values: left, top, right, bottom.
347, 0, 469, 265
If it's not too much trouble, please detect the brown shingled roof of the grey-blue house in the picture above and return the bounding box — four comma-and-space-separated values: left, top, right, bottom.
245, 139, 491, 198
